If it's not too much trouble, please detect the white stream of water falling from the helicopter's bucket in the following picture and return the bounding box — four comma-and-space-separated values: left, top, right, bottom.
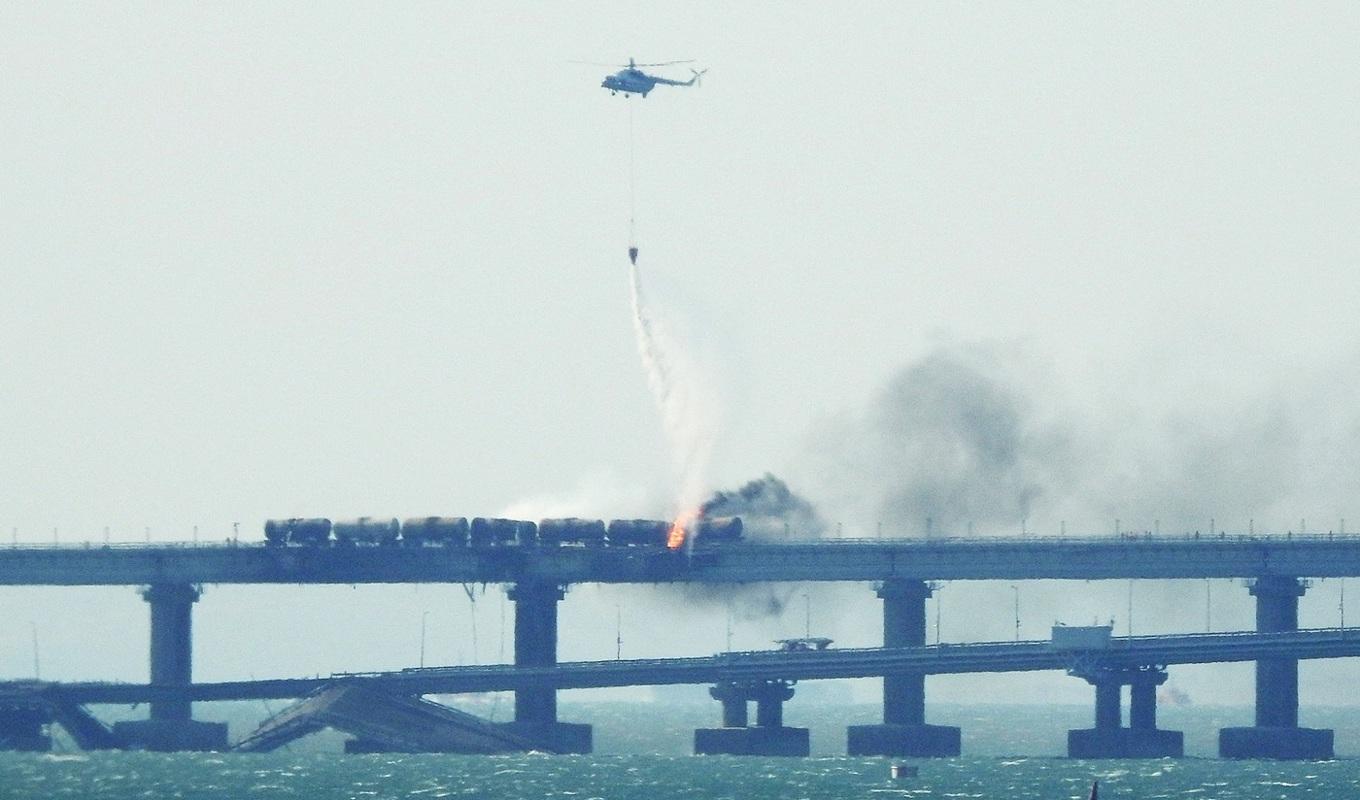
630, 264, 718, 512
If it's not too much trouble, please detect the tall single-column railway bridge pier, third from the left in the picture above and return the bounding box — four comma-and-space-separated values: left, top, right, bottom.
846, 578, 960, 758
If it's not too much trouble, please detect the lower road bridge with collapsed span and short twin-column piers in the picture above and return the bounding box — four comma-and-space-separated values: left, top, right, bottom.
13, 629, 1360, 756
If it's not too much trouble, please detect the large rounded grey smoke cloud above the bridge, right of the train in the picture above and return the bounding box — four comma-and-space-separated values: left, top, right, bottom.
817, 347, 1074, 536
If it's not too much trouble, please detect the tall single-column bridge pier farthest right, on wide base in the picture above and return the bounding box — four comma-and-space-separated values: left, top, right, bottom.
1219, 576, 1333, 759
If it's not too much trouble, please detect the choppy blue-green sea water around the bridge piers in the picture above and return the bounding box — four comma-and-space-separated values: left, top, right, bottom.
0, 703, 1360, 800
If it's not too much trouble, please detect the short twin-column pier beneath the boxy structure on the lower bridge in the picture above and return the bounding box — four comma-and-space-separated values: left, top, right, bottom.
1068, 667, 1185, 758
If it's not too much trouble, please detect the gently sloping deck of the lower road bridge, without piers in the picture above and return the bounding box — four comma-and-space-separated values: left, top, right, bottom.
39, 629, 1360, 703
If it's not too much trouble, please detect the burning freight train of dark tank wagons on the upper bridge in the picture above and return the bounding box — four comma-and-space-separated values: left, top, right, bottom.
264, 517, 743, 548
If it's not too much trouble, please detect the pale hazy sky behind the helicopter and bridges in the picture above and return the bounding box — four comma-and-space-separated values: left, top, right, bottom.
0, 3, 1360, 713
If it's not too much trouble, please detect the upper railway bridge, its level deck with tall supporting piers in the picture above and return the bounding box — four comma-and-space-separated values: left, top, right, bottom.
0, 536, 1360, 758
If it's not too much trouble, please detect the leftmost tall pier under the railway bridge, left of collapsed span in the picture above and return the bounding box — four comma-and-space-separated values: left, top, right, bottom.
113, 584, 227, 752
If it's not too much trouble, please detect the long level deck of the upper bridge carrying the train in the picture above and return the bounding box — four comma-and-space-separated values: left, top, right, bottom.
0, 536, 1360, 586
